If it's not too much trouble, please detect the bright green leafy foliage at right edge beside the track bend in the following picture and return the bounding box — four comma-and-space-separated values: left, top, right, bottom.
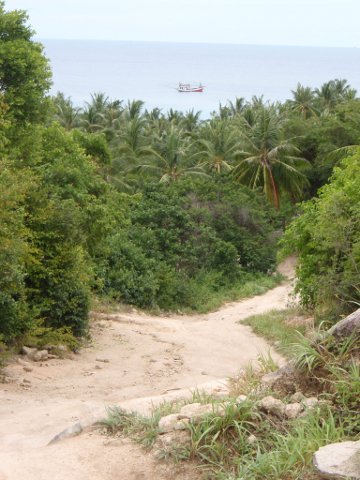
284, 153, 360, 318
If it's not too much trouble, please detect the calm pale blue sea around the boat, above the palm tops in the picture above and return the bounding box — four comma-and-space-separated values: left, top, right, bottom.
42, 40, 360, 117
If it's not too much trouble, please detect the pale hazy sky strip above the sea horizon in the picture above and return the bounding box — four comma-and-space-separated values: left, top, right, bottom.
5, 0, 360, 47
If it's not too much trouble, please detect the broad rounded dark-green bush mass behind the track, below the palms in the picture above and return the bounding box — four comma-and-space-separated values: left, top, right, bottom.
103, 179, 277, 310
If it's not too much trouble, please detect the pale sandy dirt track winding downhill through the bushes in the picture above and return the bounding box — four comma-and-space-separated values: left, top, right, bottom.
0, 261, 292, 480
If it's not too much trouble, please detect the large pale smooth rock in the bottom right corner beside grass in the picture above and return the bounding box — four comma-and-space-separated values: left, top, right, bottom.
314, 440, 360, 480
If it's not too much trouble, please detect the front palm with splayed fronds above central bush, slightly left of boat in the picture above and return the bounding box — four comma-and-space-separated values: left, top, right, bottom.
138, 126, 207, 183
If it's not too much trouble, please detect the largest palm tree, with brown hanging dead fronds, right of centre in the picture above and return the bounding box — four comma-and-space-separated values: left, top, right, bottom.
232, 106, 308, 209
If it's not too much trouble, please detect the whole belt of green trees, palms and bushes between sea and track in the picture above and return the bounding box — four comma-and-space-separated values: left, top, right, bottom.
0, 2, 360, 342
